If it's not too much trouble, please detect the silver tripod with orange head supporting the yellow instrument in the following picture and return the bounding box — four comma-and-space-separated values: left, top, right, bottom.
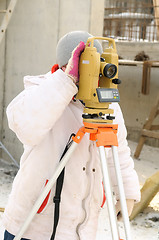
14, 121, 131, 240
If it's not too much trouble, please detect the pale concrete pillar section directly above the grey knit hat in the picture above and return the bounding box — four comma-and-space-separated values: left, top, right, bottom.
58, 0, 104, 38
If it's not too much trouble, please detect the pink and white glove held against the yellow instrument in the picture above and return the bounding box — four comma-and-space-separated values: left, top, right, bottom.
65, 42, 85, 84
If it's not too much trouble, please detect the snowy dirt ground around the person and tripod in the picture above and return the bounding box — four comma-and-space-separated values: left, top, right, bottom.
0, 141, 159, 240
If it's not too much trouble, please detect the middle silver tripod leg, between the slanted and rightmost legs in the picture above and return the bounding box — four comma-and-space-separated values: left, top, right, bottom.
99, 146, 119, 240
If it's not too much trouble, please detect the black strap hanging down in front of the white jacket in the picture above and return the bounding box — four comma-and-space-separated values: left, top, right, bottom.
50, 134, 75, 240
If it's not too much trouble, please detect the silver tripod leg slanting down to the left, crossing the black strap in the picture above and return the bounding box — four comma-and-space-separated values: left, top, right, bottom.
13, 142, 78, 240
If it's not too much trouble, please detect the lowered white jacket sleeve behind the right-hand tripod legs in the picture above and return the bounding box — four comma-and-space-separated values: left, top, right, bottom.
108, 103, 140, 202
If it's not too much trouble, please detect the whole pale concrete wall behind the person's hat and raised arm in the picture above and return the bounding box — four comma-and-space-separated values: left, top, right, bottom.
0, 0, 104, 160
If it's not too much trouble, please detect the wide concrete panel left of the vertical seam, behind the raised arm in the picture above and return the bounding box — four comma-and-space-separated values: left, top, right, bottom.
2, 0, 59, 161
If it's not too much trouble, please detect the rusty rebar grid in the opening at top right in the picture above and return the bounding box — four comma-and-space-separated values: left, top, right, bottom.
103, 0, 159, 42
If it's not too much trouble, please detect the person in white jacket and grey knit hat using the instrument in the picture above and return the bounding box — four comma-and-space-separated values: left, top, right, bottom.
3, 31, 140, 240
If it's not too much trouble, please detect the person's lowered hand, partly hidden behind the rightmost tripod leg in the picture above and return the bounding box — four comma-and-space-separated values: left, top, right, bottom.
115, 199, 134, 221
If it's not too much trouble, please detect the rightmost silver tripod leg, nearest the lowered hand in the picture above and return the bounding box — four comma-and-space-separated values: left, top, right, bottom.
112, 146, 131, 240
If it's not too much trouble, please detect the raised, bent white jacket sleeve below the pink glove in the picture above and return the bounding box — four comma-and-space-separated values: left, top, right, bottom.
7, 70, 78, 146
